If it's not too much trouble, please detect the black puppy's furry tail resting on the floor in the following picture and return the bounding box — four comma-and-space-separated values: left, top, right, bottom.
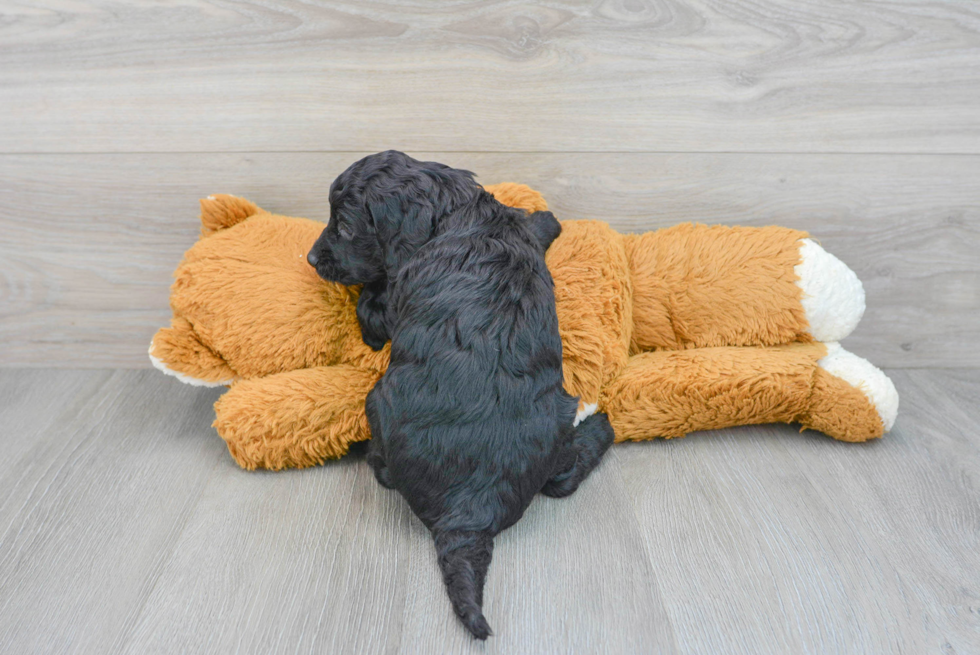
433, 530, 493, 639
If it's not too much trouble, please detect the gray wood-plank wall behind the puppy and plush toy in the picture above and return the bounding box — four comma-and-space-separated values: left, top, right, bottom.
0, 0, 980, 367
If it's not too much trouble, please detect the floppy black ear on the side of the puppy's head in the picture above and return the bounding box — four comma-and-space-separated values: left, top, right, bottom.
367, 193, 436, 278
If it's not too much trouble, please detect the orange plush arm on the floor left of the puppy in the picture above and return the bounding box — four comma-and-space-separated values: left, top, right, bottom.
214, 365, 380, 471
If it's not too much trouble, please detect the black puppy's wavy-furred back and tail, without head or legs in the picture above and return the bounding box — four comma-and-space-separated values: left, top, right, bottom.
368, 194, 577, 639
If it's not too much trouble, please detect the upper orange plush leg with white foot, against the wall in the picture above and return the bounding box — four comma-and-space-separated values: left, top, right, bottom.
625, 224, 864, 353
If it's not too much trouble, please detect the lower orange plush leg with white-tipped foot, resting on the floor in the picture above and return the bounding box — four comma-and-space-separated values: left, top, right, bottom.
600, 343, 898, 441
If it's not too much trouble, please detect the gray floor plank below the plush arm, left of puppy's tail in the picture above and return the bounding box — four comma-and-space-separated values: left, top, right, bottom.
123, 458, 416, 654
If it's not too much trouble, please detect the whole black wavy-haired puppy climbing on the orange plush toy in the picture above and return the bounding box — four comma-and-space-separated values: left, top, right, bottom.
308, 151, 613, 639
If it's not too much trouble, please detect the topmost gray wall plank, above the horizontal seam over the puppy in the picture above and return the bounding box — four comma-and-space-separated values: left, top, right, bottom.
0, 0, 980, 154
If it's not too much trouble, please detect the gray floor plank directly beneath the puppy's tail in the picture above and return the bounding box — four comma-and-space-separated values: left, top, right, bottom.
399, 461, 679, 653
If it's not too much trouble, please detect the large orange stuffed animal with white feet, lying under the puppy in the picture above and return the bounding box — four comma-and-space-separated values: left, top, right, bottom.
150, 183, 898, 469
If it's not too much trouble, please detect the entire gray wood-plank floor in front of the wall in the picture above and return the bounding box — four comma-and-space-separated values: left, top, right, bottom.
0, 370, 980, 654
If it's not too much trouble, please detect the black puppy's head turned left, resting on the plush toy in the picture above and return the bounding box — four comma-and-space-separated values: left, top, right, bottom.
307, 150, 480, 284
